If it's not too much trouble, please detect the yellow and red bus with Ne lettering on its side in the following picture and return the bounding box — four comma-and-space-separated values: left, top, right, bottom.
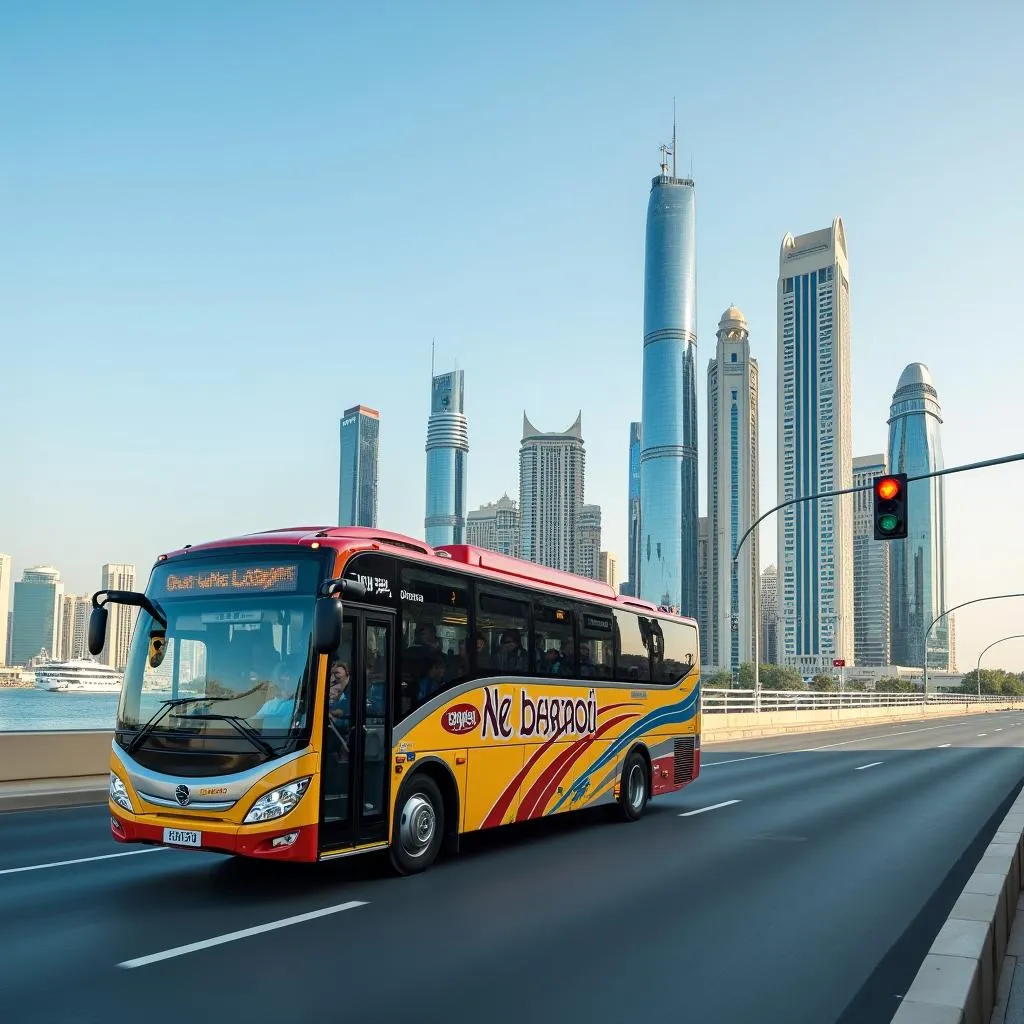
89, 526, 700, 873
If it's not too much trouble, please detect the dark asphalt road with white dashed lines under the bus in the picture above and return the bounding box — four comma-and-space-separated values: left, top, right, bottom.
0, 712, 1024, 1024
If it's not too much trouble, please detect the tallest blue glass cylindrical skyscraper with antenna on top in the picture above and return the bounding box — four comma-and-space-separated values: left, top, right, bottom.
635, 129, 697, 616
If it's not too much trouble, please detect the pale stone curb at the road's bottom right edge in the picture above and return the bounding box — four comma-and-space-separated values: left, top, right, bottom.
892, 791, 1024, 1024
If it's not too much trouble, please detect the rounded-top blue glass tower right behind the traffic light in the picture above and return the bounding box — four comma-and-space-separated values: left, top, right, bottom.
878, 362, 949, 672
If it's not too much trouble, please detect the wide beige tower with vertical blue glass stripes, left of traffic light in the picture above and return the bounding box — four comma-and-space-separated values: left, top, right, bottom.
777, 217, 854, 675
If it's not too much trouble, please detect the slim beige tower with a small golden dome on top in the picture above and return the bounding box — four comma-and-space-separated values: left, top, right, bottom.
708, 306, 759, 673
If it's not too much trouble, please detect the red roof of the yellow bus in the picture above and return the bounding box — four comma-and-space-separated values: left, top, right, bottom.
159, 526, 695, 624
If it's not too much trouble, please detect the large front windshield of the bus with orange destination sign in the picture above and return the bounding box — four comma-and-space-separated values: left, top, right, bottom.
117, 552, 322, 757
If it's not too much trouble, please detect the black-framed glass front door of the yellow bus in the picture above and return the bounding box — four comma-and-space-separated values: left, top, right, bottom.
319, 605, 395, 854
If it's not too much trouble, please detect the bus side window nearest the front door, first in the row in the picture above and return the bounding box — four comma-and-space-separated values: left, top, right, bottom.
398, 566, 471, 716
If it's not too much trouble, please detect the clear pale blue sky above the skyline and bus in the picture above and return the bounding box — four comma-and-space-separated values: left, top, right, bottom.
0, 0, 1024, 670
